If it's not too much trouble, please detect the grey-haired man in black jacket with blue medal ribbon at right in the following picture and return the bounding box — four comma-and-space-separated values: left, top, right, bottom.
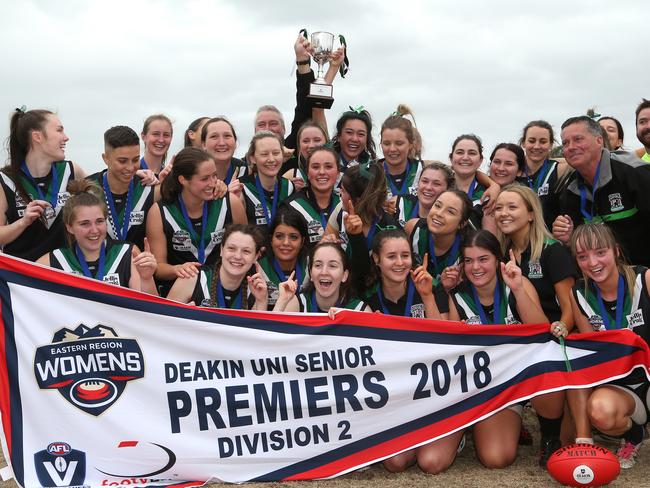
553, 116, 650, 266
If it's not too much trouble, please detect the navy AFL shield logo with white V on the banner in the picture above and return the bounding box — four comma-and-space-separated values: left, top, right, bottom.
34, 442, 86, 487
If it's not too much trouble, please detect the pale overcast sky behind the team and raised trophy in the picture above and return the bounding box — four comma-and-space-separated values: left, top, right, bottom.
0, 0, 650, 171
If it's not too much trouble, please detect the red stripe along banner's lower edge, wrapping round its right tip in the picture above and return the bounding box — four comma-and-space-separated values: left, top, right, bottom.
285, 331, 650, 481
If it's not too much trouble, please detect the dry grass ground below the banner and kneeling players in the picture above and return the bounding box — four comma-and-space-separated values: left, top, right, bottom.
0, 409, 650, 488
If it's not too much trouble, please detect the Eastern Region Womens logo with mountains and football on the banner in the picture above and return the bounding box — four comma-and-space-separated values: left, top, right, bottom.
34, 324, 144, 415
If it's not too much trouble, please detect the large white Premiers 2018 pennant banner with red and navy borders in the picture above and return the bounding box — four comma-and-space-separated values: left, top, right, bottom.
0, 257, 649, 487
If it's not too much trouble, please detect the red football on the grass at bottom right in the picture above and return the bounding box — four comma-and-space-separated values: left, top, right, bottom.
546, 444, 621, 487
